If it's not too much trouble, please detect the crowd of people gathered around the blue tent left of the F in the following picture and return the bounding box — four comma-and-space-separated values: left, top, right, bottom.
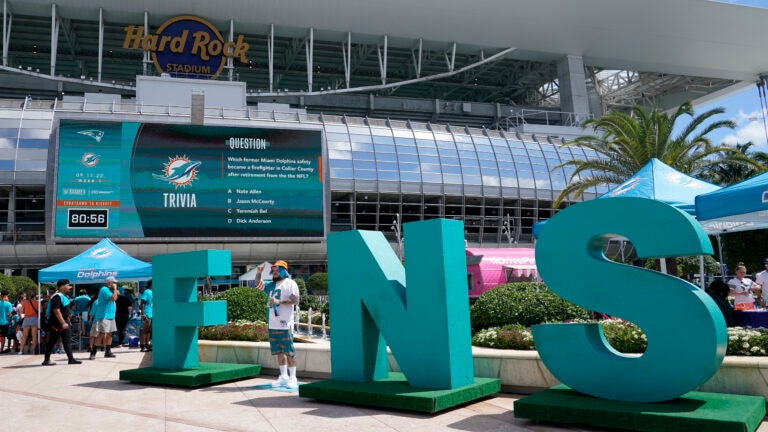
0, 276, 154, 366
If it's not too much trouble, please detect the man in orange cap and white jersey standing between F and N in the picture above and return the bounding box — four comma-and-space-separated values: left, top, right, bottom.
256, 260, 299, 389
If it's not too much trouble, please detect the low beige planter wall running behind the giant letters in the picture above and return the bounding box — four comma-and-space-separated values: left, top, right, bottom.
198, 340, 768, 398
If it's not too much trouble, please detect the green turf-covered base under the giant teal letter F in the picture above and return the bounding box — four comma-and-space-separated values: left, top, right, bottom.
120, 362, 261, 387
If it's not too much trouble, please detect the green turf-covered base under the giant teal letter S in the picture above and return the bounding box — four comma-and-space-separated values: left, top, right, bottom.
514, 385, 765, 432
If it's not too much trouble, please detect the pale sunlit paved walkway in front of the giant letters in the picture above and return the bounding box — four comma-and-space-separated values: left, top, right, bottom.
0, 348, 768, 432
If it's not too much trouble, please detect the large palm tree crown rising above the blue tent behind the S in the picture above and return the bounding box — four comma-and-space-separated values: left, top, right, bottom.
553, 102, 760, 208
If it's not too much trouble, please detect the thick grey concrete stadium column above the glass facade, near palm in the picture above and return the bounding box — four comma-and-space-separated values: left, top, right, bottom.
557, 55, 589, 125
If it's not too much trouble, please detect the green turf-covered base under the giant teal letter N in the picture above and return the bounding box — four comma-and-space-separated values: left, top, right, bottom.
299, 372, 501, 413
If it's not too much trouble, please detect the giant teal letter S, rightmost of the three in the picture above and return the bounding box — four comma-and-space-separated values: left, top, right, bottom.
533, 198, 728, 402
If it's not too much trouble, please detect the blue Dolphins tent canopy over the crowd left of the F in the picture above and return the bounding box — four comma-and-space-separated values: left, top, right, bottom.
38, 238, 152, 284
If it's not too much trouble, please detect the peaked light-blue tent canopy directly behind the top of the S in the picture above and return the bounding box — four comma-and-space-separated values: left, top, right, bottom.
533, 158, 721, 238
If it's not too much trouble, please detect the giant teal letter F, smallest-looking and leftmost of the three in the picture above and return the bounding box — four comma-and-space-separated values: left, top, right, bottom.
152, 250, 232, 369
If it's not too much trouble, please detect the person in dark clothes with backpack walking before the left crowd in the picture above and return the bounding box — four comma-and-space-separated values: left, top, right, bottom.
43, 279, 82, 366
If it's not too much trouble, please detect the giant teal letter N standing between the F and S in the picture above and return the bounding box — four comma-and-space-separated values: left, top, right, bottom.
328, 219, 474, 389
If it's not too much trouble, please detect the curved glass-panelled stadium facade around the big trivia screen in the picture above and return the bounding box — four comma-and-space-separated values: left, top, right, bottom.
0, 100, 604, 274
